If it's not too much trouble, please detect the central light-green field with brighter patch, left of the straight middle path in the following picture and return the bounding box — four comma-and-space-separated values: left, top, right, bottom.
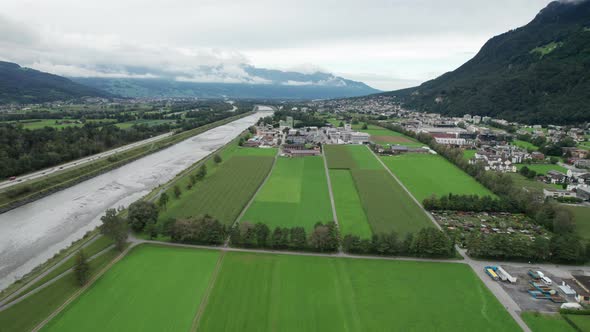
241, 156, 334, 232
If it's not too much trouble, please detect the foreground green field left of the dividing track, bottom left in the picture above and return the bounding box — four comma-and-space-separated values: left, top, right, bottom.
42, 245, 220, 332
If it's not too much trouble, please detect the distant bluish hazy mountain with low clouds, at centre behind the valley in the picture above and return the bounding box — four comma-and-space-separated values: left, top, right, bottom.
72, 65, 379, 99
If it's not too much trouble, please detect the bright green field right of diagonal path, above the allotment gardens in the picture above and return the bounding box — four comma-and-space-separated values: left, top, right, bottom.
381, 153, 493, 202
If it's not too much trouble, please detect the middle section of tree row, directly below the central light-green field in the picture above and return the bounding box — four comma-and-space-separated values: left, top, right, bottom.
230, 221, 340, 252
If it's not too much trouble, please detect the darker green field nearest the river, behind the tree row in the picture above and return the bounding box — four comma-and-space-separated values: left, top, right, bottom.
159, 147, 277, 226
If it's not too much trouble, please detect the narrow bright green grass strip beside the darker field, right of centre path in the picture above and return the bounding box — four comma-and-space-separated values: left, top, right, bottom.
330, 169, 372, 239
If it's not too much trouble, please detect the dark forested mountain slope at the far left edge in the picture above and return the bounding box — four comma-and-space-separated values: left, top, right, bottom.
0, 61, 109, 104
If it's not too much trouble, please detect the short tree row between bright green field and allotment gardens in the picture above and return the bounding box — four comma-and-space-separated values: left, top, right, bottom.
422, 194, 519, 212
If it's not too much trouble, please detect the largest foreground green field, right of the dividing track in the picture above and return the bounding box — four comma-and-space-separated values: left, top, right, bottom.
198, 252, 520, 332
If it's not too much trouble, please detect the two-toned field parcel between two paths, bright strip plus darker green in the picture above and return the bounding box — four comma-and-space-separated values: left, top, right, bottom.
324, 145, 432, 236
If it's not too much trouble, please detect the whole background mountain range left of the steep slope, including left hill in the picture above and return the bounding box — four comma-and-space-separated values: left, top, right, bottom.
0, 62, 379, 104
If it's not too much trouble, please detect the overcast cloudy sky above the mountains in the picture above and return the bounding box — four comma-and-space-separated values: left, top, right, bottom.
0, 0, 549, 90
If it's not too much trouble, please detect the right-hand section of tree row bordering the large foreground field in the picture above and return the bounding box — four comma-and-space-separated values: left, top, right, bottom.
342, 227, 455, 258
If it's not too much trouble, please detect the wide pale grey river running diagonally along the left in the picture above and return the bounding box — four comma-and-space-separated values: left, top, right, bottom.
0, 112, 272, 290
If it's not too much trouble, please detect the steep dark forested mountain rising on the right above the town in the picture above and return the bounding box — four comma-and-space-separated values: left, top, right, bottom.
386, 0, 590, 123
